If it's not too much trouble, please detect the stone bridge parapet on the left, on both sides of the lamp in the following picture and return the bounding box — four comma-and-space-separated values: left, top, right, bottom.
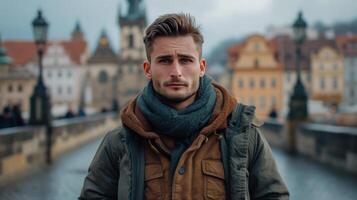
0, 113, 119, 185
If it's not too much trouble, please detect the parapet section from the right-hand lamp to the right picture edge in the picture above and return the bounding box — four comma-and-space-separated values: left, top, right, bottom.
297, 124, 357, 173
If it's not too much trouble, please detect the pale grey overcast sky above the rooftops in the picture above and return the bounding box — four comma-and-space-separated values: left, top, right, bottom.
0, 0, 357, 53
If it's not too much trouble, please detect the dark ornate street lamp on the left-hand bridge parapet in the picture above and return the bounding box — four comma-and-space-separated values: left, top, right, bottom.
30, 10, 51, 125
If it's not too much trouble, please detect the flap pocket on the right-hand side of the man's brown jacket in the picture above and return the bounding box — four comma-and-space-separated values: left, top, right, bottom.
202, 160, 226, 199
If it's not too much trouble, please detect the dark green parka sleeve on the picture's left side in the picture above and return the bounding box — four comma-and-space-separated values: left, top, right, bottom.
79, 131, 121, 199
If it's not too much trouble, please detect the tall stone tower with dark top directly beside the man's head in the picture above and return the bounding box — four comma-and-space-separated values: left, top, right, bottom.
117, 1, 147, 106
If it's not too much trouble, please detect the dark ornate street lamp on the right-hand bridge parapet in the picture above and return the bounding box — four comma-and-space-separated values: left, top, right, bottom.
288, 12, 308, 121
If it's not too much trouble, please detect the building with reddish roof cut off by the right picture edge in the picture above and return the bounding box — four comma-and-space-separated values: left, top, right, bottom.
336, 35, 357, 108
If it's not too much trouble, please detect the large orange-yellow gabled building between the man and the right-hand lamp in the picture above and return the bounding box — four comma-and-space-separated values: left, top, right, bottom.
229, 35, 283, 119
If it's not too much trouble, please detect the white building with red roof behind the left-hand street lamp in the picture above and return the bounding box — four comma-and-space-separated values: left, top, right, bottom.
4, 23, 88, 116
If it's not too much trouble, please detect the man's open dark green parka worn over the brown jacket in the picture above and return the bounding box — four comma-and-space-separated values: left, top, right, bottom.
79, 104, 289, 200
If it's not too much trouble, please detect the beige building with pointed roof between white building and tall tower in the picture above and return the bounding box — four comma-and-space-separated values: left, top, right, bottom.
84, 31, 118, 112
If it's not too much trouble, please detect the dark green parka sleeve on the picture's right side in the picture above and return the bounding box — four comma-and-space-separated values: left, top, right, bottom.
249, 126, 289, 200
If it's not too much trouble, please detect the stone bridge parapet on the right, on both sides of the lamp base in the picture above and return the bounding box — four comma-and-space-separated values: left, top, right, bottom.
262, 119, 357, 173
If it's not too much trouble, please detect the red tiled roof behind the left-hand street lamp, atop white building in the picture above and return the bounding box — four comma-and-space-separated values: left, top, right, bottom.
3, 40, 87, 66
